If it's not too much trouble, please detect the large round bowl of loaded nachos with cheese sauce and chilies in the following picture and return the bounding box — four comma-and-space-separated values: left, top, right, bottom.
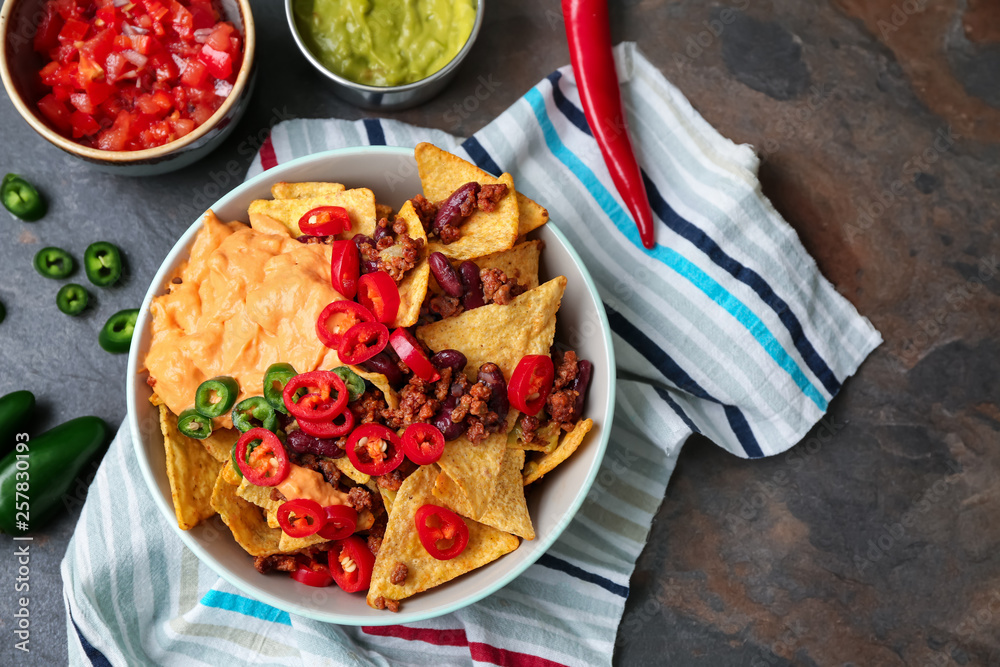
127, 143, 615, 625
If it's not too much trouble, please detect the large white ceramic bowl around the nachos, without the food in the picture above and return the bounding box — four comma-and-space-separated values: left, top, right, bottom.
127, 146, 615, 625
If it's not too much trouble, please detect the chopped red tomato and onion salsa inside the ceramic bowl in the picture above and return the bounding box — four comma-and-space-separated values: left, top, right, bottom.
34, 0, 243, 151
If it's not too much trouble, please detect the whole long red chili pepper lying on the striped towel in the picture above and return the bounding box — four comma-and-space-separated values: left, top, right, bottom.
562, 0, 656, 250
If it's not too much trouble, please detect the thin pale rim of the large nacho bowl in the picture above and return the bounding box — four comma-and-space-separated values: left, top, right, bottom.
125, 146, 617, 626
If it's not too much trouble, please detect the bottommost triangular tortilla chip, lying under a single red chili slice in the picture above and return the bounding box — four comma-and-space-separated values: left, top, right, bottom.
368, 465, 520, 607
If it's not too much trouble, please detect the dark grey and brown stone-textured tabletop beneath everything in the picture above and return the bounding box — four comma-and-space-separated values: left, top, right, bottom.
0, 0, 1000, 665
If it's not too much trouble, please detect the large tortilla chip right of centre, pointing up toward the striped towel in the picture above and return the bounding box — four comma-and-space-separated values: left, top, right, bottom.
417, 276, 566, 380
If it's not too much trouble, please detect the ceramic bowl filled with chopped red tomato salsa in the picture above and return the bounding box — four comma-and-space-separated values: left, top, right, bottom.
0, 0, 255, 175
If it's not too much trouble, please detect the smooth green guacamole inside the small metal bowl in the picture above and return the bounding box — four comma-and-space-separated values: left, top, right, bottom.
294, 0, 476, 86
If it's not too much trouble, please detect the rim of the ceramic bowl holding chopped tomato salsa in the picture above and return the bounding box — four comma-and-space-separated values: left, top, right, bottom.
0, 0, 257, 165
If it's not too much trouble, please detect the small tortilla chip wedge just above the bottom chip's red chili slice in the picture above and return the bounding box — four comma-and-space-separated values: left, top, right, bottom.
438, 433, 507, 521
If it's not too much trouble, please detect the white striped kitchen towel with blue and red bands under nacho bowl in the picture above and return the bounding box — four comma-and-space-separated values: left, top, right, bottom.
62, 44, 881, 667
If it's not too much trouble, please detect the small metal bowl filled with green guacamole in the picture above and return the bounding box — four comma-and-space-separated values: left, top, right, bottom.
285, 0, 483, 111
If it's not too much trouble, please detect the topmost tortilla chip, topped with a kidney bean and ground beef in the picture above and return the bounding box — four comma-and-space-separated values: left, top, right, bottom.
414, 143, 518, 260
